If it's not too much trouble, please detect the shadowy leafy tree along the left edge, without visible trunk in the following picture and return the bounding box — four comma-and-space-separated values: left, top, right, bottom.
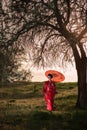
0, 1, 32, 83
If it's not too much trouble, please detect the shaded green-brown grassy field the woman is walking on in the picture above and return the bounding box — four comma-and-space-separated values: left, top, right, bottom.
0, 83, 87, 130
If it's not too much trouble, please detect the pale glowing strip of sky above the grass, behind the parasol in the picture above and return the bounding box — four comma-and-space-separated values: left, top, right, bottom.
32, 66, 77, 82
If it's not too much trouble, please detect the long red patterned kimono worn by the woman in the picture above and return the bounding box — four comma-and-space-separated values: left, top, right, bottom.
43, 81, 56, 111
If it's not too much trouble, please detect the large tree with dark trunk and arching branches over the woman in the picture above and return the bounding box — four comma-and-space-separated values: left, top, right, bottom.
0, 0, 87, 108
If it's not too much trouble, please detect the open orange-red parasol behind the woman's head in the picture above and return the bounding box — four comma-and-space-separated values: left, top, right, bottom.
45, 70, 65, 82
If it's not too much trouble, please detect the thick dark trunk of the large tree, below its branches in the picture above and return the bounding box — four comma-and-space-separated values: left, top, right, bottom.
71, 40, 87, 108
